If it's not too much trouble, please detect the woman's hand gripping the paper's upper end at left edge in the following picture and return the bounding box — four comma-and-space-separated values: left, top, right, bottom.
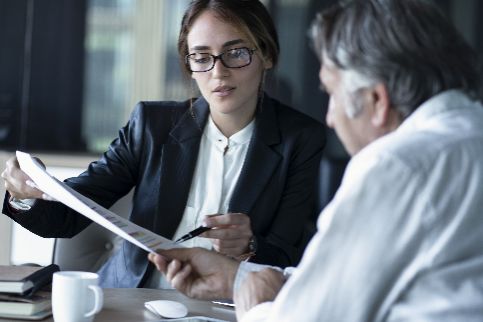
2, 157, 47, 200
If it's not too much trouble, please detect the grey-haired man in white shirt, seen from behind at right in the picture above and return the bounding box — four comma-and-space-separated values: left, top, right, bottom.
149, 0, 483, 322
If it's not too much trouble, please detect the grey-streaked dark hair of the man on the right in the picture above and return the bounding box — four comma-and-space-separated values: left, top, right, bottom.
313, 0, 480, 117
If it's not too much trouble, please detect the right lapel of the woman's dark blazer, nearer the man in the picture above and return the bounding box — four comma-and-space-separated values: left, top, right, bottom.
229, 96, 282, 214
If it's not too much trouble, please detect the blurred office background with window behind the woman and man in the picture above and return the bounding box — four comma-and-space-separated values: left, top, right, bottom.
0, 0, 483, 264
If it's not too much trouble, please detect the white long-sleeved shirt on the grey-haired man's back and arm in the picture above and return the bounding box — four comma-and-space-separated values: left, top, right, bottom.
242, 91, 483, 322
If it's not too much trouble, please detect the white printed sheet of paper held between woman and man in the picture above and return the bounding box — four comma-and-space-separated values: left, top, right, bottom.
17, 151, 181, 252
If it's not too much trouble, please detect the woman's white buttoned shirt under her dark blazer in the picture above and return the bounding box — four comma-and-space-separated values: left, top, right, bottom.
145, 117, 255, 288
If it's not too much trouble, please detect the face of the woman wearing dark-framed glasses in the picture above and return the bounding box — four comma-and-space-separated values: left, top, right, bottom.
187, 10, 271, 123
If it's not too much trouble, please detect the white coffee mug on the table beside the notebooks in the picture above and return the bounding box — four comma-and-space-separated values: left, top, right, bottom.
52, 271, 104, 322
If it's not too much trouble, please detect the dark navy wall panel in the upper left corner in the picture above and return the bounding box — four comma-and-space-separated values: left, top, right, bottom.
0, 0, 86, 151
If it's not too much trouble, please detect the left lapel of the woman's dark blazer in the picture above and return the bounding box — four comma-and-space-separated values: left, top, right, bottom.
154, 98, 209, 238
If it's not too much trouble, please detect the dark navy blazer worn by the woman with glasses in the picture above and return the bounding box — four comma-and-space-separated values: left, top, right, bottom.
3, 96, 325, 287
